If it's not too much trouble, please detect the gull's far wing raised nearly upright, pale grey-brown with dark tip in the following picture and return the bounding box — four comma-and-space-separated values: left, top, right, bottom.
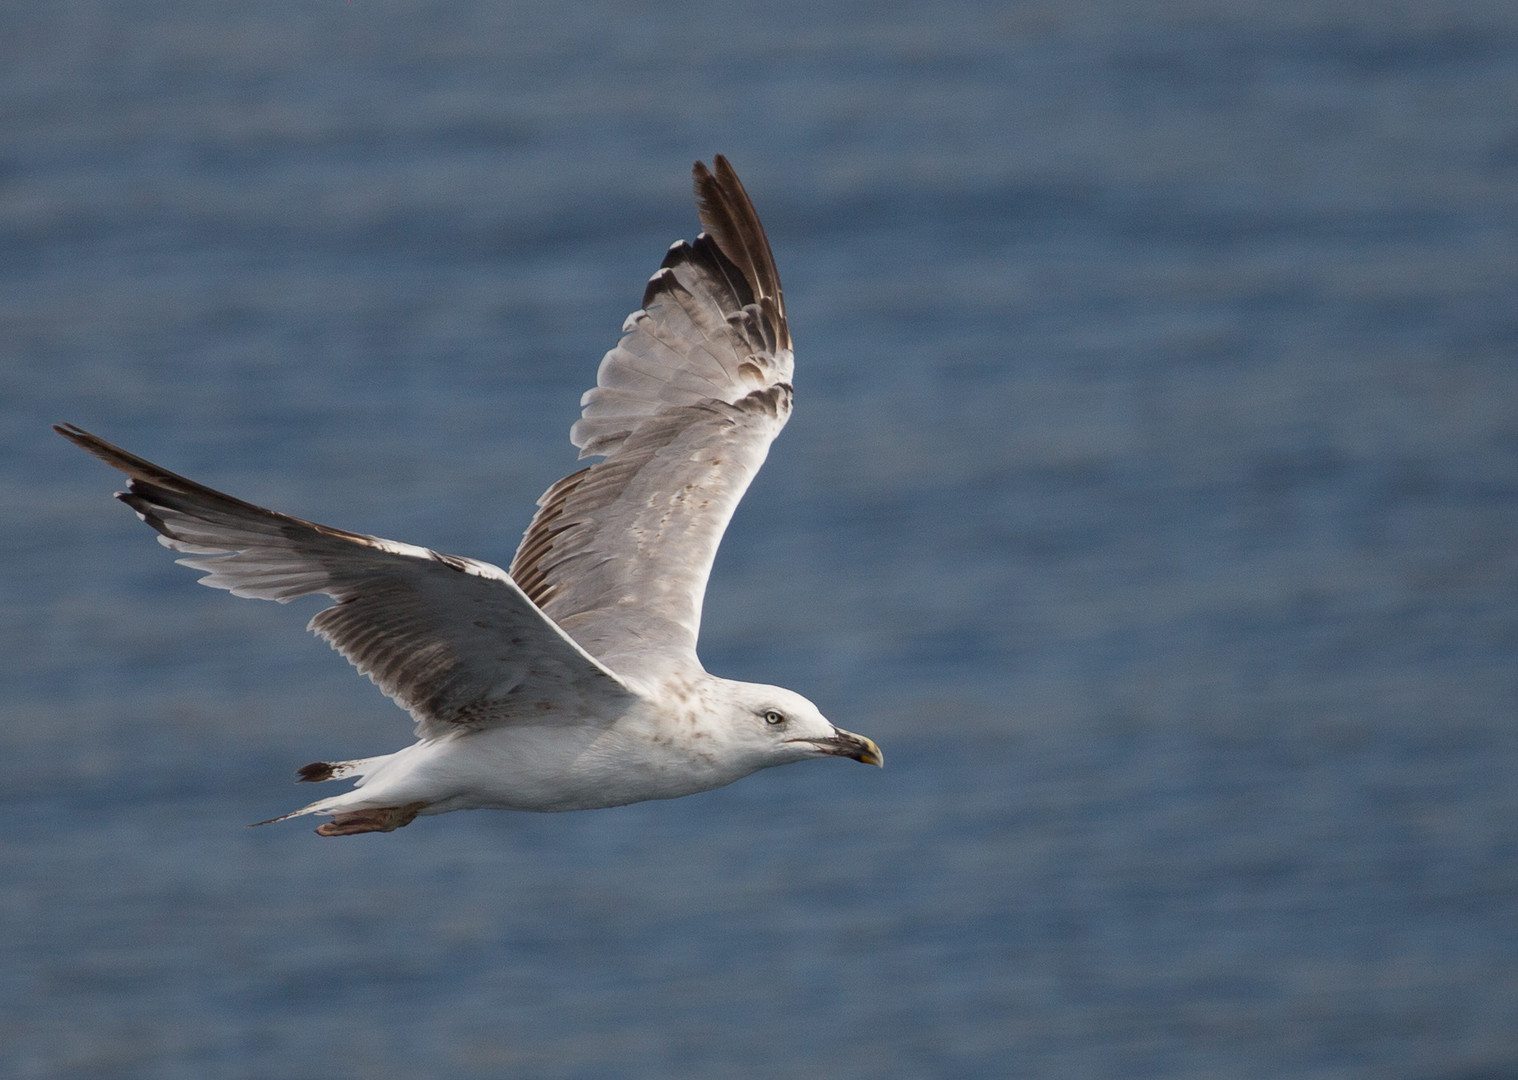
512, 155, 792, 676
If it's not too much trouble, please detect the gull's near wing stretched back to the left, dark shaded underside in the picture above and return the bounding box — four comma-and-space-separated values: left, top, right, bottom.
53, 425, 631, 737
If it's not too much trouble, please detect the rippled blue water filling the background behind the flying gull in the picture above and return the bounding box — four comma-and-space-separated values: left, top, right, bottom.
0, 0, 1518, 1080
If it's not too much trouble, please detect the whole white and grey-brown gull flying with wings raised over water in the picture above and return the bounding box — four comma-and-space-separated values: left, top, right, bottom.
53, 155, 883, 837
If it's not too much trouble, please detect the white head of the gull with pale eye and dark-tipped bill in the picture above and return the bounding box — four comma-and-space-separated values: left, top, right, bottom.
713, 679, 883, 772
